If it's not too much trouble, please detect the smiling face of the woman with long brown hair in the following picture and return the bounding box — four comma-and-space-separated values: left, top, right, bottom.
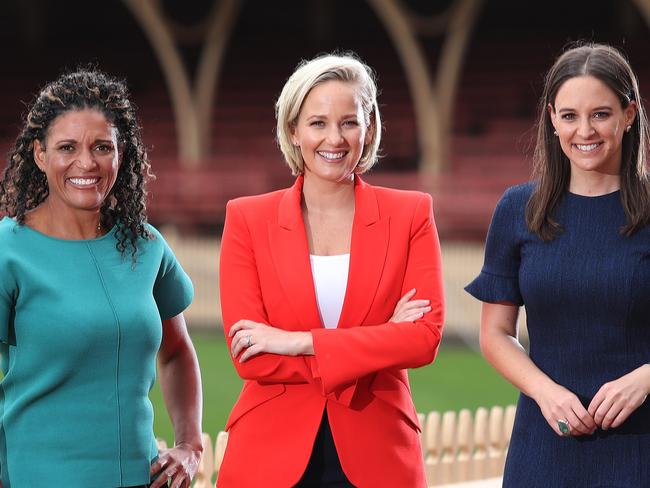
548, 76, 636, 178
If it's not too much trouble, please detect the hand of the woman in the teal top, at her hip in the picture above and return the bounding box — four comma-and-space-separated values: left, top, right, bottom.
150, 442, 202, 488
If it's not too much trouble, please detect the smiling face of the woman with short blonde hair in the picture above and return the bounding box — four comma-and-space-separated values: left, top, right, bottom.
292, 81, 372, 182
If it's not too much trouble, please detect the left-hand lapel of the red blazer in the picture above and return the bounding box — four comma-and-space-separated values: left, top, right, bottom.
269, 176, 322, 330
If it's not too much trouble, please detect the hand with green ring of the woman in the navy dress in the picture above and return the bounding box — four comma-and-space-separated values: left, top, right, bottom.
533, 382, 597, 436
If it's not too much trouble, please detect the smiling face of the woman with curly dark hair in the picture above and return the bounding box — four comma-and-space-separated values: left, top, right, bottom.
34, 109, 120, 214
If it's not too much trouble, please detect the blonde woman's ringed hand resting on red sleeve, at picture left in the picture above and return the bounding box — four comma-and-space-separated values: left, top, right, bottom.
228, 320, 314, 363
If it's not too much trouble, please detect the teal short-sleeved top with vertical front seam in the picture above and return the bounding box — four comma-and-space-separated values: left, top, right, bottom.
0, 217, 194, 488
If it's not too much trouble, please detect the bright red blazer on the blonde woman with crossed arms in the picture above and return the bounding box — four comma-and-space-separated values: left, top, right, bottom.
217, 177, 444, 488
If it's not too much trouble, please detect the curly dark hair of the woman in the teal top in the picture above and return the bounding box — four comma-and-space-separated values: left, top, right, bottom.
0, 68, 153, 264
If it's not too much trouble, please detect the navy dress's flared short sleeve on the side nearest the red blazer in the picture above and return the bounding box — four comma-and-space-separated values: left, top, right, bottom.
465, 189, 524, 305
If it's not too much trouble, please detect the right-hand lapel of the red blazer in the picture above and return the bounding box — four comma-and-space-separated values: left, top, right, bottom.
338, 176, 389, 328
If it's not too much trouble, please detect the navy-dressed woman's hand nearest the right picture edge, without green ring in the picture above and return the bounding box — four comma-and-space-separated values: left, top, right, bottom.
588, 364, 650, 430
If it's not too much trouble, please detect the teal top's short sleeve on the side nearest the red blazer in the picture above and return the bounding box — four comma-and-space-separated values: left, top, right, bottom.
153, 232, 194, 320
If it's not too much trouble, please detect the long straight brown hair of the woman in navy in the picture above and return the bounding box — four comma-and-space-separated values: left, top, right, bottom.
526, 44, 650, 241
